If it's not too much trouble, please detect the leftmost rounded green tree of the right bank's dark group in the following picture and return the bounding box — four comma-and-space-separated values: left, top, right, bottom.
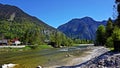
96, 25, 106, 45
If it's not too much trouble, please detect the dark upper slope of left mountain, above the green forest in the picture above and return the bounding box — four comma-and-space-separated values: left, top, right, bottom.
0, 4, 54, 29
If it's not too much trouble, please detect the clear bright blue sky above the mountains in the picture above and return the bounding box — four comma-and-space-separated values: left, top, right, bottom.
0, 0, 115, 28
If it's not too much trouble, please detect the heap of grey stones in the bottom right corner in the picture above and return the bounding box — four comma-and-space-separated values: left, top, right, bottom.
80, 52, 120, 68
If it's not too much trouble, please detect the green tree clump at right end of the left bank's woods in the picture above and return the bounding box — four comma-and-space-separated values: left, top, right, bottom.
50, 31, 73, 47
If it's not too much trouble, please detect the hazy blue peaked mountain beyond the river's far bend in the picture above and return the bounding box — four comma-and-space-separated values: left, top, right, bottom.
57, 17, 106, 40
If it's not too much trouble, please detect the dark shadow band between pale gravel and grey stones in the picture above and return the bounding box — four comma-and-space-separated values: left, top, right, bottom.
56, 51, 120, 68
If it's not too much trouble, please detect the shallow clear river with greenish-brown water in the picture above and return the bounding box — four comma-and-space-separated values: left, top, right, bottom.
0, 45, 93, 68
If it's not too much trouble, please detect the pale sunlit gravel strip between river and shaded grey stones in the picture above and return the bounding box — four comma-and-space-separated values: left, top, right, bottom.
44, 47, 109, 68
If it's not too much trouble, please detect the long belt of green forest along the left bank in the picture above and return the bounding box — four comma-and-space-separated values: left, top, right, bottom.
0, 20, 73, 47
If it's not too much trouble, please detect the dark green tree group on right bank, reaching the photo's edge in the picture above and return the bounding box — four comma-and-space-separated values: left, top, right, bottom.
95, 0, 120, 51
